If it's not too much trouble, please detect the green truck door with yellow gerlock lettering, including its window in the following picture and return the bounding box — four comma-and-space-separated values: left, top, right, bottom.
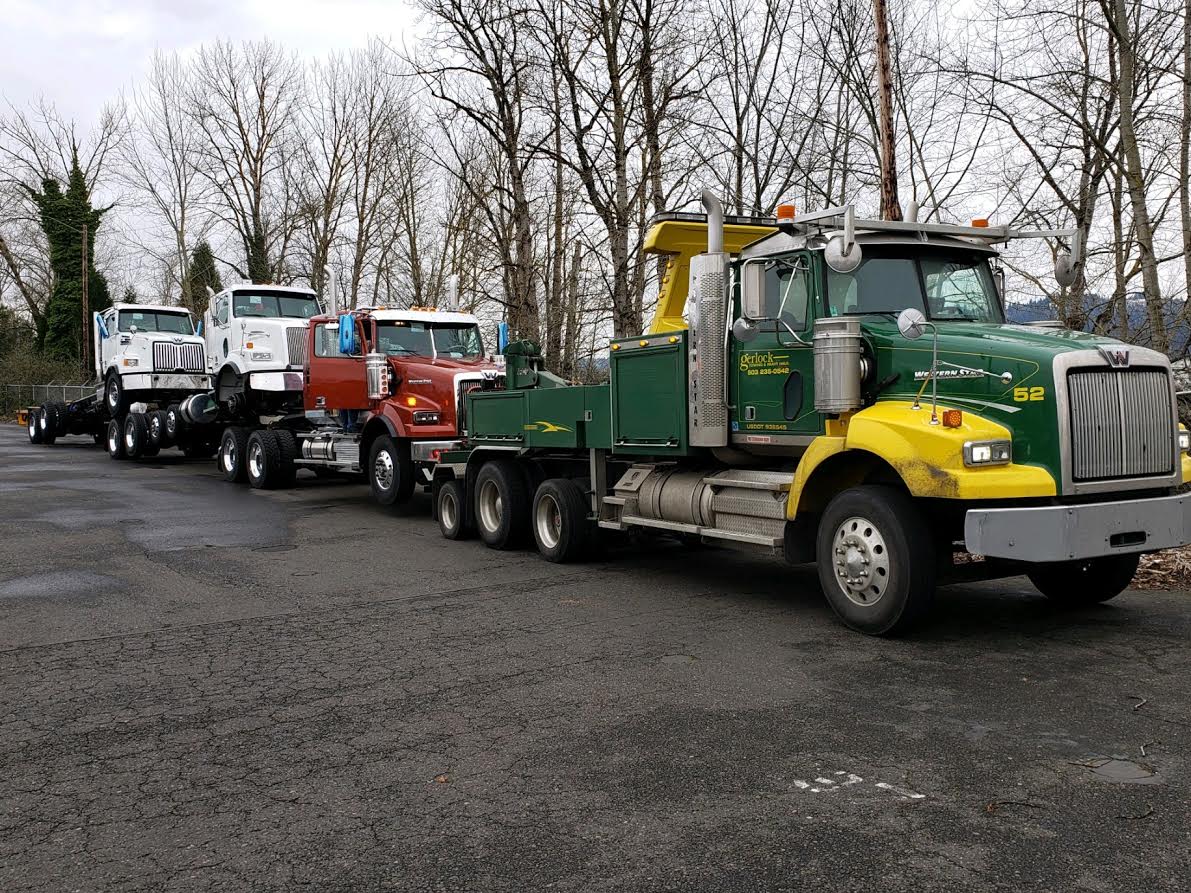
731, 254, 823, 445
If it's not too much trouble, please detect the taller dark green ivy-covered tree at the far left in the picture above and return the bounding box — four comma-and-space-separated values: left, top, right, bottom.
30, 154, 112, 361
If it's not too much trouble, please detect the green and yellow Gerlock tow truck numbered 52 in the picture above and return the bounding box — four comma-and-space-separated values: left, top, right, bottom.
434, 193, 1191, 635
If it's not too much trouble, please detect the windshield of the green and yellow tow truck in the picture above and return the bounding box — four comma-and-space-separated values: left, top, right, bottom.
827, 245, 1004, 323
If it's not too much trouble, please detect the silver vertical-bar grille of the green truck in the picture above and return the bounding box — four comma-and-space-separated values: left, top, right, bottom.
1067, 369, 1174, 481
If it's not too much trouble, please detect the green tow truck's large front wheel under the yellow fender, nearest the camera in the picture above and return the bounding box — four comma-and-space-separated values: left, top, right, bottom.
816, 485, 935, 636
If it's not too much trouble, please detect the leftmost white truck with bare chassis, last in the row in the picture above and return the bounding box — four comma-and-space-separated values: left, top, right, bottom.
29, 304, 214, 458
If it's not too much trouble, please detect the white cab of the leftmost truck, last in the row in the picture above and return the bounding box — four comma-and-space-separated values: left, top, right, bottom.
94, 304, 210, 419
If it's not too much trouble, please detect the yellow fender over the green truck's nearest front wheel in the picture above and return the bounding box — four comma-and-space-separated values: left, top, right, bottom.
786, 400, 1057, 519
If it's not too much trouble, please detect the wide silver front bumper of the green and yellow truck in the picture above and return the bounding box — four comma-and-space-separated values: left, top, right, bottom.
964, 493, 1191, 562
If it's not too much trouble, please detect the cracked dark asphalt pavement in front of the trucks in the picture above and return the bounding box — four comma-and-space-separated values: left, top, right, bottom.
0, 425, 1191, 893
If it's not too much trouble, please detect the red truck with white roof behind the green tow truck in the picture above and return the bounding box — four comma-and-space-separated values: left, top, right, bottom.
181, 297, 499, 505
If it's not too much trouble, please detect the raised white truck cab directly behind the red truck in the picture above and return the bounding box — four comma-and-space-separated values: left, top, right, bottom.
204, 283, 319, 419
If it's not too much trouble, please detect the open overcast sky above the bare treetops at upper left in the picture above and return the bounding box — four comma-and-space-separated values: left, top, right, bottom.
0, 0, 414, 127
